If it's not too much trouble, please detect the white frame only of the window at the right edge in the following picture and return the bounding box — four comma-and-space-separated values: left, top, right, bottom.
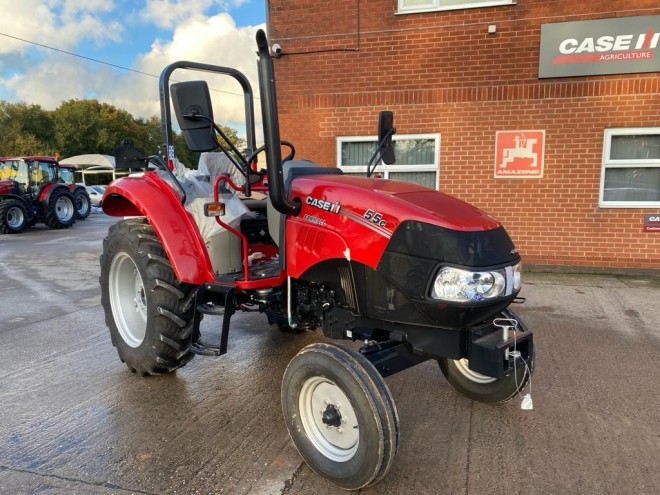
598, 127, 660, 208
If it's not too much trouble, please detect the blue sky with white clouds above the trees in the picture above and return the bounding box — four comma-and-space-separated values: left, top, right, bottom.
0, 0, 266, 136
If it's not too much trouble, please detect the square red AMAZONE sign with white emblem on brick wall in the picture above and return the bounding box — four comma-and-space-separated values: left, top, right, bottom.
495, 131, 545, 179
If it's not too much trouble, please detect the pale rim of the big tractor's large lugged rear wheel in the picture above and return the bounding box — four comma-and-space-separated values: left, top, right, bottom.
108, 253, 147, 348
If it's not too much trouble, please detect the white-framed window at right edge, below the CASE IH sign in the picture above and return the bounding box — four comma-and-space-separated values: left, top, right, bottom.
599, 127, 660, 208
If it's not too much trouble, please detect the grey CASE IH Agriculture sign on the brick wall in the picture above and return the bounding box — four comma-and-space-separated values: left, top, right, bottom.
539, 15, 660, 78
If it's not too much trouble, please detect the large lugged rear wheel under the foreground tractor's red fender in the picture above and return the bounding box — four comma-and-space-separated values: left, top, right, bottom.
99, 219, 197, 376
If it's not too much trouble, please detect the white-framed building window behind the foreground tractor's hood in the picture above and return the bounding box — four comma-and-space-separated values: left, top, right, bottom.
337, 134, 440, 189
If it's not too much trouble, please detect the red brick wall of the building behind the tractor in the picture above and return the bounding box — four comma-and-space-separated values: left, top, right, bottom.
269, 0, 660, 270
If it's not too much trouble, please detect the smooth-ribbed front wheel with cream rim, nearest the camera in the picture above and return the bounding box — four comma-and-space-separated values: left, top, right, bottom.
282, 343, 399, 490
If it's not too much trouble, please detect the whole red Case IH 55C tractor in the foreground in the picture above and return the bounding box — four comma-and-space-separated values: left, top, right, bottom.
100, 31, 534, 490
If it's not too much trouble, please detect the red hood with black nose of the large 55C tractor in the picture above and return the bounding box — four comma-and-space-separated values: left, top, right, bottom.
287, 174, 519, 276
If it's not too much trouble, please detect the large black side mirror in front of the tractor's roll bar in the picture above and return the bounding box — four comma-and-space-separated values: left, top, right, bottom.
170, 81, 218, 151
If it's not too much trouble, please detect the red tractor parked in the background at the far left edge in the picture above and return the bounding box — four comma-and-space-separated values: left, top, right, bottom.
0, 156, 76, 234
